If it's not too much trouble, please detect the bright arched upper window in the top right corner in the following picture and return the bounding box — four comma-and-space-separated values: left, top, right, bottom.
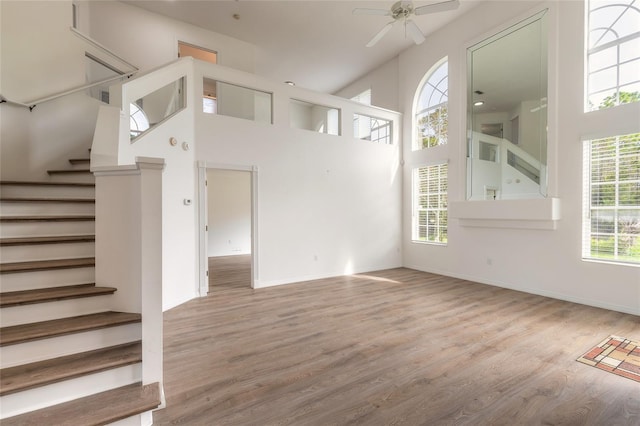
586, 0, 640, 111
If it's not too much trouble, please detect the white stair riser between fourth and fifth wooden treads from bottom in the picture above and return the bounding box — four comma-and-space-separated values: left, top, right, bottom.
0, 267, 95, 291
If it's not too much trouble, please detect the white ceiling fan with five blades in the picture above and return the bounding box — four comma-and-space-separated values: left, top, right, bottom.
353, 0, 459, 47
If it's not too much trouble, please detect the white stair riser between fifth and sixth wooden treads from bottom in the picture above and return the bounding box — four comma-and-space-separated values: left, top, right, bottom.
0, 242, 95, 263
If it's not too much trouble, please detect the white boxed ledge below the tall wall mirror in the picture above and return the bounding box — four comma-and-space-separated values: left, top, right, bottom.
449, 197, 561, 230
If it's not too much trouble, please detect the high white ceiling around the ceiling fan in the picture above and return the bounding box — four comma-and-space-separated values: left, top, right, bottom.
125, 0, 480, 93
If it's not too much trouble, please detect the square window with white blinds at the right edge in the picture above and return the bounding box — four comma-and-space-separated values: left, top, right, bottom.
582, 133, 640, 263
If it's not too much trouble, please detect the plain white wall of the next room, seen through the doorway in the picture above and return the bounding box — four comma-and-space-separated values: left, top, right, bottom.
207, 169, 251, 257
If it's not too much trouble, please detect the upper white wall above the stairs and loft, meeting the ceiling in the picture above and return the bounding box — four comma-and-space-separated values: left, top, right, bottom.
79, 1, 255, 72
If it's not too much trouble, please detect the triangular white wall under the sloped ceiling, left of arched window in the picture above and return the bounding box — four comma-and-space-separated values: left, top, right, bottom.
335, 56, 400, 111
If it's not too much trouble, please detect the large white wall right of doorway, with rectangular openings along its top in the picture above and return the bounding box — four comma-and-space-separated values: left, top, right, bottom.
195, 63, 401, 287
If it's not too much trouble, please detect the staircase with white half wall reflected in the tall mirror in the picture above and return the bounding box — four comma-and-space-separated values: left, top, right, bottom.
468, 132, 546, 200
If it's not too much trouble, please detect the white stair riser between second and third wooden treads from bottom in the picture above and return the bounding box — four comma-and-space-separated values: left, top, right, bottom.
0, 323, 142, 368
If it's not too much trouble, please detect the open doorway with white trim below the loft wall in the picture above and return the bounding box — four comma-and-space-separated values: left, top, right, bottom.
199, 164, 257, 296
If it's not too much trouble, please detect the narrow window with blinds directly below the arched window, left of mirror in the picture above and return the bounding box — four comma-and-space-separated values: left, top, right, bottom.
412, 164, 448, 244
